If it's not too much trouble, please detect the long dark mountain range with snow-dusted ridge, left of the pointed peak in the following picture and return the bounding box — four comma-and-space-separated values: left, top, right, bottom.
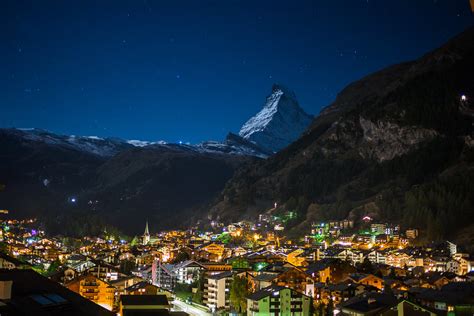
0, 129, 257, 235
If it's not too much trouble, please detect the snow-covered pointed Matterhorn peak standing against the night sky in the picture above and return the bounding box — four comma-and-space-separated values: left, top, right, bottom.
239, 84, 313, 152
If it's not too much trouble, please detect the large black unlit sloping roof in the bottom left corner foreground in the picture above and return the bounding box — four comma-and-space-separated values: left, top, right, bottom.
0, 269, 114, 316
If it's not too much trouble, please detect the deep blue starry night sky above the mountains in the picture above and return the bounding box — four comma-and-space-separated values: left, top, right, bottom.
0, 0, 473, 143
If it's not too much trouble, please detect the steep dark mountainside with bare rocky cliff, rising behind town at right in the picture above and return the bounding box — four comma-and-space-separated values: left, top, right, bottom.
212, 28, 474, 244
